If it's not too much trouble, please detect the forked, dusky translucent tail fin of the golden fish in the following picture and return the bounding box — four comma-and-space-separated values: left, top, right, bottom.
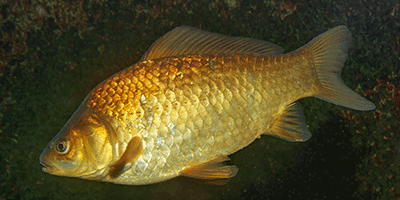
302, 26, 375, 111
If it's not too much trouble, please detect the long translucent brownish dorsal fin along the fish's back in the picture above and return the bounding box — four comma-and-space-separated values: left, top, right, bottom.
140, 26, 285, 61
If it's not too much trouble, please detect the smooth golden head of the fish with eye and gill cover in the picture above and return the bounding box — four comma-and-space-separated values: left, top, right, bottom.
40, 102, 113, 179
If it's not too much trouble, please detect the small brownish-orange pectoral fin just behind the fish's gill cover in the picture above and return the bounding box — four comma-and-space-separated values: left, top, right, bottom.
108, 136, 143, 178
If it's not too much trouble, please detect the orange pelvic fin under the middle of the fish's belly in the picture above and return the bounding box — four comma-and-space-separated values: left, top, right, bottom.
181, 156, 239, 182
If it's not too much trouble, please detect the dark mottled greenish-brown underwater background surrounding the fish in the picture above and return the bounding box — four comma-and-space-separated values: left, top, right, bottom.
0, 0, 400, 200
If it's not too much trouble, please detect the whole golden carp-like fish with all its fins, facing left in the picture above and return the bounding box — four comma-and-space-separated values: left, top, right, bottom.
40, 25, 375, 185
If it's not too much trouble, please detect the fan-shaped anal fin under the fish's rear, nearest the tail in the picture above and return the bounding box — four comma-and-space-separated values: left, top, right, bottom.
265, 102, 311, 142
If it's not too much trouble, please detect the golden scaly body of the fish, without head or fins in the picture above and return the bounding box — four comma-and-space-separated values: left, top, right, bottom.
87, 52, 312, 184
